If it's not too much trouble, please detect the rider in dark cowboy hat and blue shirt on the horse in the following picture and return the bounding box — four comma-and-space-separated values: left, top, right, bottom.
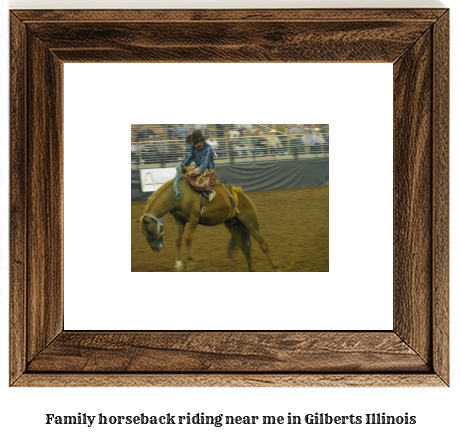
177, 130, 216, 201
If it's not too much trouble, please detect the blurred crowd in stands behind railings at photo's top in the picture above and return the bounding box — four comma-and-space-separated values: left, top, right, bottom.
131, 124, 329, 164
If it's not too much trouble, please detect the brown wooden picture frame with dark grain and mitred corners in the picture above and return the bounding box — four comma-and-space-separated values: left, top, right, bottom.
10, 9, 449, 386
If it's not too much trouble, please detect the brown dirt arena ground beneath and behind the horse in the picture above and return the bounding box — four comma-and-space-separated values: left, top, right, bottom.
131, 186, 329, 272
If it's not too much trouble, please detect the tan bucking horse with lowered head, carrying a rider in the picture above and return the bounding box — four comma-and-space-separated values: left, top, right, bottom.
139, 171, 280, 272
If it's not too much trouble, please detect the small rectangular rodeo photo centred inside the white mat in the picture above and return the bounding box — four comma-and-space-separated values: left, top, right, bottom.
131, 124, 329, 272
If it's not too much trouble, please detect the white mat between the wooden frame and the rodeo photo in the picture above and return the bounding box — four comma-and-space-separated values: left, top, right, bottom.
64, 64, 393, 330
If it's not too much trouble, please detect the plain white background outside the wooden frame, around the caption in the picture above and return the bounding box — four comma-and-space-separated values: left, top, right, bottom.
0, 0, 461, 435
